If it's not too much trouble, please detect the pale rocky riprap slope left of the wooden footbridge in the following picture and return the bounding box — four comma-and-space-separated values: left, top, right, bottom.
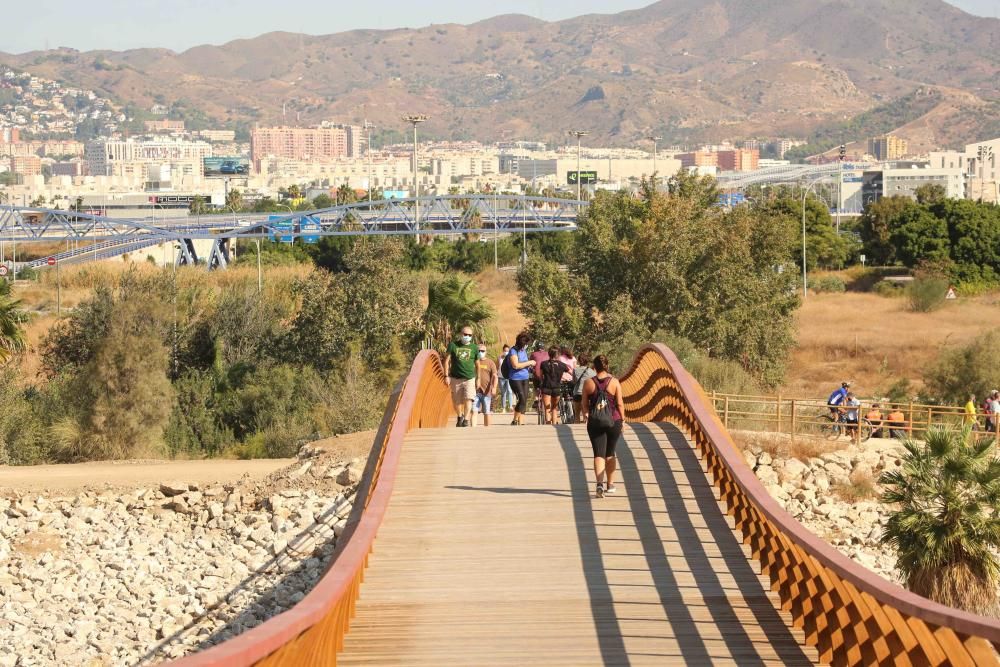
0, 449, 363, 667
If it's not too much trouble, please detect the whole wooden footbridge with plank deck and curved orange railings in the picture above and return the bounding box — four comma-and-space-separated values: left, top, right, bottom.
175, 345, 1000, 667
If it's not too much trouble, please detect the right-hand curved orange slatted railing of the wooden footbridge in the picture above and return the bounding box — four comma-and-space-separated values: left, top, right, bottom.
621, 345, 1000, 665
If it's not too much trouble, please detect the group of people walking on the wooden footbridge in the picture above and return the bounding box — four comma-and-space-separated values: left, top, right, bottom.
444, 326, 625, 498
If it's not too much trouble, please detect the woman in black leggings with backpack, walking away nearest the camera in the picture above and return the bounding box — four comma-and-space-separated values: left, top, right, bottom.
582, 354, 625, 498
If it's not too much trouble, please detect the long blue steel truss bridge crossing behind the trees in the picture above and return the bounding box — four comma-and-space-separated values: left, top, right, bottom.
0, 194, 587, 268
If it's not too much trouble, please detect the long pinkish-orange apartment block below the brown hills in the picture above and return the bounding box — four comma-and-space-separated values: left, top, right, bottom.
250, 125, 363, 169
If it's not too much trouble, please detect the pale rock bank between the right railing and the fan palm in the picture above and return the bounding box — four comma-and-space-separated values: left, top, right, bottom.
743, 437, 904, 583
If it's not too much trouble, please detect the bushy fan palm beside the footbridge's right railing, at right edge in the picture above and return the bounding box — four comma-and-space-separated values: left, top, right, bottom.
879, 429, 1000, 614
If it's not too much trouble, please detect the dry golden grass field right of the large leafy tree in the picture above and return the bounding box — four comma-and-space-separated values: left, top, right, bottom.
781, 292, 1000, 397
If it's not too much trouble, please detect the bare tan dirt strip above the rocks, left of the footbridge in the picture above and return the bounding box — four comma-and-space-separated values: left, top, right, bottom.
0, 431, 375, 495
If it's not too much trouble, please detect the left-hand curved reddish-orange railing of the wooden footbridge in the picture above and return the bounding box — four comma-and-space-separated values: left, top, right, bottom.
171, 350, 452, 667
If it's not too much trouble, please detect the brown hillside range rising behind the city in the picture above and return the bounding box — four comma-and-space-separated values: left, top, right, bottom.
0, 0, 1000, 147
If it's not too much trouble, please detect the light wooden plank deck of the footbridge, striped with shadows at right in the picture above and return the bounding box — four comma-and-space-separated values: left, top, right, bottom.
338, 424, 816, 666
